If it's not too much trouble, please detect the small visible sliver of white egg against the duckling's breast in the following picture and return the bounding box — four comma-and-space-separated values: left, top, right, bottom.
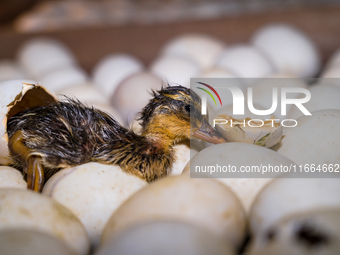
170, 140, 198, 175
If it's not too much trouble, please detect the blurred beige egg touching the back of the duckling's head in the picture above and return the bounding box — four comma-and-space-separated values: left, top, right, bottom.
111, 72, 164, 124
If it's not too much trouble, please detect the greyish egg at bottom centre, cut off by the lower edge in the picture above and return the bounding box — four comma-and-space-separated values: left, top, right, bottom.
96, 220, 235, 255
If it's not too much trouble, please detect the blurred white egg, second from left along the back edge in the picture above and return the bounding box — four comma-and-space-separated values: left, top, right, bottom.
93, 53, 144, 98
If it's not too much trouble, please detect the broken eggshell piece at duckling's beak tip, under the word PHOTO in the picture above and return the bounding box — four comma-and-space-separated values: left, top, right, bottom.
216, 114, 283, 148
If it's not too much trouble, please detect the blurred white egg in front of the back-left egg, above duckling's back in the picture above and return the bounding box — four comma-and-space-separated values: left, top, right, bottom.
40, 66, 87, 93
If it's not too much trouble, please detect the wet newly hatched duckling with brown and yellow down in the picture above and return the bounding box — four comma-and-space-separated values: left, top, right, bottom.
7, 86, 225, 191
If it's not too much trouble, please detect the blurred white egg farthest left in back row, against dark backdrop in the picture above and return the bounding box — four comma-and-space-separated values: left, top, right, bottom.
18, 38, 76, 79
